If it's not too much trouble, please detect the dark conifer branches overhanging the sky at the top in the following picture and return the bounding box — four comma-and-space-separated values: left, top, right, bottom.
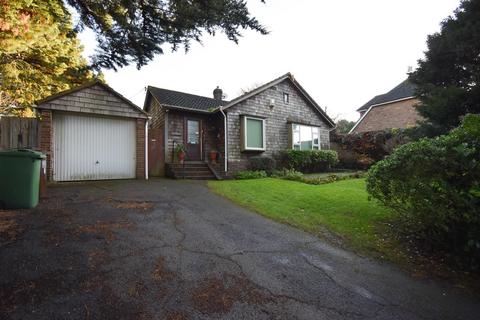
66, 0, 267, 70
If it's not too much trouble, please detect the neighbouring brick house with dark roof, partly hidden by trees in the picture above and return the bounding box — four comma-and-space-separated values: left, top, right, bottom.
350, 80, 422, 133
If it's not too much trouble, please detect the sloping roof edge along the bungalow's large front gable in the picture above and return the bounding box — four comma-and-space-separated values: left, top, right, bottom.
223, 72, 335, 128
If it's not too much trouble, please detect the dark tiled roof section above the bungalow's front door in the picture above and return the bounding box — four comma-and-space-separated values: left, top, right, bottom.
148, 86, 228, 111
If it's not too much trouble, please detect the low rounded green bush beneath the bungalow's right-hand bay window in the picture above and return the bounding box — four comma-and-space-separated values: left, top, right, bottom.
280, 150, 338, 172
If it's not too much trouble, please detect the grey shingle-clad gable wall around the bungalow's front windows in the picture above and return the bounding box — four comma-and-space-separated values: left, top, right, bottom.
226, 80, 330, 173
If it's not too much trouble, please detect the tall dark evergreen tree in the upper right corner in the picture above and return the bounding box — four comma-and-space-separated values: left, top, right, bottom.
409, 0, 480, 135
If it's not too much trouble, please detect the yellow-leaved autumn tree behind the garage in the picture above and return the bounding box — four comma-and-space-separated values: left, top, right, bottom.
0, 0, 94, 114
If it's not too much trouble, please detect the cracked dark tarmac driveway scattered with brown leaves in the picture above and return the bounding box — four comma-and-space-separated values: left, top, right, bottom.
0, 179, 480, 320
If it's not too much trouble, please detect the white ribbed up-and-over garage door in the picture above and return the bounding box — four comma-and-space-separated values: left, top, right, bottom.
53, 113, 136, 181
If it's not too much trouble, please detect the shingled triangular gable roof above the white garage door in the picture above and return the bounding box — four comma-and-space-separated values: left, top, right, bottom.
37, 80, 148, 119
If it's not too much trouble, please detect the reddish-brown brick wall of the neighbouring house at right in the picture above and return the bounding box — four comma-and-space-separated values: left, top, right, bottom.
354, 99, 422, 132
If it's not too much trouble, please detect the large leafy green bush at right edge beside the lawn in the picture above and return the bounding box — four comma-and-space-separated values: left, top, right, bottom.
367, 115, 480, 268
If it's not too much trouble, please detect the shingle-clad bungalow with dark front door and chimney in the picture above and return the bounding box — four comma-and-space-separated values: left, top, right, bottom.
144, 73, 334, 178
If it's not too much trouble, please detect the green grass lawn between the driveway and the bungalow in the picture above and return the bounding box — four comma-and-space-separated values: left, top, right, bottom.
208, 178, 405, 262
